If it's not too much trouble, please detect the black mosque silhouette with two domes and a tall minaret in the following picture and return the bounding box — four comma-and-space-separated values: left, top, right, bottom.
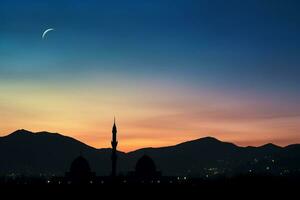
56, 120, 162, 184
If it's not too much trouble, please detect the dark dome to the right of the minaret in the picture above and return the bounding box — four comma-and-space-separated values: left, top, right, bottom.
135, 155, 156, 176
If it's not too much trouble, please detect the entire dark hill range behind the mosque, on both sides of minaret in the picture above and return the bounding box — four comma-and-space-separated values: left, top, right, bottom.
0, 130, 300, 178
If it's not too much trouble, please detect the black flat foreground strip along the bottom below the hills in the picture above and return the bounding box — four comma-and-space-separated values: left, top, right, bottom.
0, 177, 300, 199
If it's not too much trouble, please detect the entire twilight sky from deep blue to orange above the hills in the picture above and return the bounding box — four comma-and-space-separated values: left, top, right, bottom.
0, 0, 300, 152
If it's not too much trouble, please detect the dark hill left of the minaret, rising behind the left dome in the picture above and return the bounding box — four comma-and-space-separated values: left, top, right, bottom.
0, 130, 123, 175
